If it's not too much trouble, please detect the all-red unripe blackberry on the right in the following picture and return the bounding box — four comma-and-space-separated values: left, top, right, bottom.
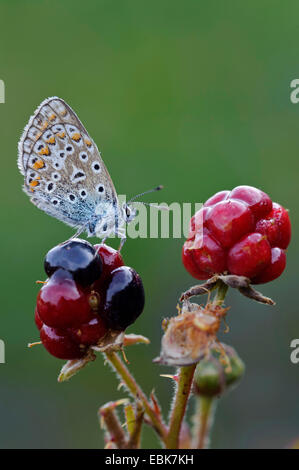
182, 186, 291, 284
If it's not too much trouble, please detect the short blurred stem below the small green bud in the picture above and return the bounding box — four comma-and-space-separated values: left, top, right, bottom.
193, 396, 216, 449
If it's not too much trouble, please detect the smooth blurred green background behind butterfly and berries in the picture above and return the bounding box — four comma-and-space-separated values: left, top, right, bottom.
0, 0, 299, 448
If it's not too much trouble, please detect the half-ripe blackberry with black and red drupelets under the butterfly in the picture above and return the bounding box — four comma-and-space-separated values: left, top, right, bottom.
35, 239, 144, 359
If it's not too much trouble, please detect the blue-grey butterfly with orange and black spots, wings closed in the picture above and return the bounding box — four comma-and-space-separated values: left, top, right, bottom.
18, 97, 162, 248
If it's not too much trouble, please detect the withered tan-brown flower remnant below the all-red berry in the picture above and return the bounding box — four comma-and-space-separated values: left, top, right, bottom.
154, 301, 228, 366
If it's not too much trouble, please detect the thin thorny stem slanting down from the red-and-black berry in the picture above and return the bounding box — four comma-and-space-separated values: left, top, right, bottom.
104, 352, 167, 442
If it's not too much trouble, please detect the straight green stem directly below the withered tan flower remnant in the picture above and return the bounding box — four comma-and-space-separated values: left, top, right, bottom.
166, 364, 196, 449
